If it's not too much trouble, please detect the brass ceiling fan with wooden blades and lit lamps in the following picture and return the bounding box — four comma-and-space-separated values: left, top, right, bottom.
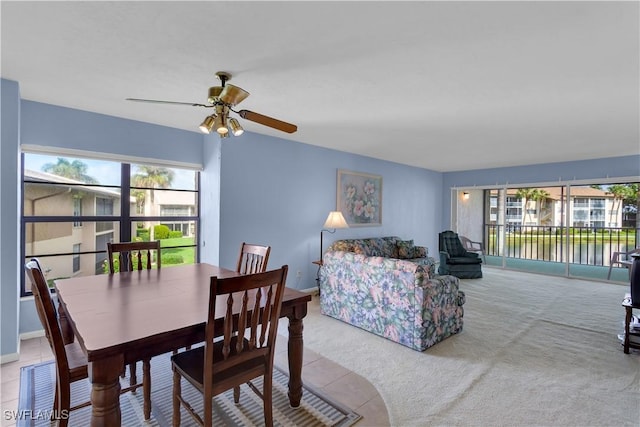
127, 71, 298, 138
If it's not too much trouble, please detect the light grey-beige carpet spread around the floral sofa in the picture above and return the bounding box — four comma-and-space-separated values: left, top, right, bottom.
304, 268, 640, 427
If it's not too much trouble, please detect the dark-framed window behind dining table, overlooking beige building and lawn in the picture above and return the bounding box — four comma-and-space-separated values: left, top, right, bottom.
21, 153, 200, 295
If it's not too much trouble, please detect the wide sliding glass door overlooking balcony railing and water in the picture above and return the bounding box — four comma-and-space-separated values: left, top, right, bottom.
453, 182, 640, 281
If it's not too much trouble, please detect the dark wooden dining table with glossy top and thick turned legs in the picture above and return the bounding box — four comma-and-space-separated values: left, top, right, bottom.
54, 263, 311, 427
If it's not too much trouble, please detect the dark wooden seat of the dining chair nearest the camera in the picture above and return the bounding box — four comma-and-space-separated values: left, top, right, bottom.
171, 339, 266, 394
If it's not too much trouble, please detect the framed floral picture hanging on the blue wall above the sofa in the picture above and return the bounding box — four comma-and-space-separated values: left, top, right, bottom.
336, 169, 382, 227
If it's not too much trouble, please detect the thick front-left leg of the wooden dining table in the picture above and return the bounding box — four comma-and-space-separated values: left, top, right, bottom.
89, 354, 124, 427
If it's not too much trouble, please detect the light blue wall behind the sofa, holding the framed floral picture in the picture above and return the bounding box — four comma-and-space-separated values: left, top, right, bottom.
220, 134, 442, 289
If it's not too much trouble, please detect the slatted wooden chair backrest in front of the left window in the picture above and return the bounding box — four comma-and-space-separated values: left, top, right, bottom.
107, 240, 162, 274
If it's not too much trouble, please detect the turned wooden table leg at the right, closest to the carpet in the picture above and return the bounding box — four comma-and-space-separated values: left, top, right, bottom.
287, 303, 307, 408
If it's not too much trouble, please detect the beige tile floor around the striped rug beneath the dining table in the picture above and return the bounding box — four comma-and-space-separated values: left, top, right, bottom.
0, 322, 389, 427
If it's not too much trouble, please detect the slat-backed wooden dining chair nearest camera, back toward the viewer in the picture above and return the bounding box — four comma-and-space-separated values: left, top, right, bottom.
171, 265, 288, 427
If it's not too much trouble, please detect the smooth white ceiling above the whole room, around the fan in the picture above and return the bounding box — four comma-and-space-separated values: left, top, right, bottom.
1, 1, 640, 172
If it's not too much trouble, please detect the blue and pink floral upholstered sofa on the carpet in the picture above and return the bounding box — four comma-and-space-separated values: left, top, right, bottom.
320, 236, 465, 351
